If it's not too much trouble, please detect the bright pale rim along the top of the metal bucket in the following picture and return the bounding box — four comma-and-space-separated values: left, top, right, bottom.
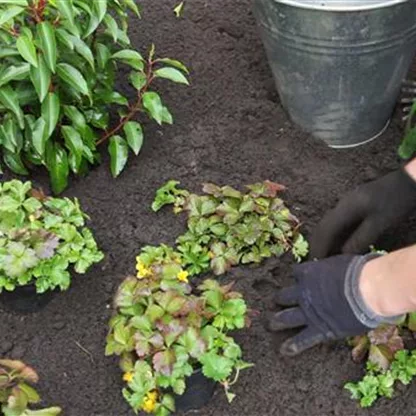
275, 0, 409, 12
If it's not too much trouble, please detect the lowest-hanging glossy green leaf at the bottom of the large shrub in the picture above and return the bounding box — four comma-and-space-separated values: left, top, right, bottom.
46, 142, 69, 194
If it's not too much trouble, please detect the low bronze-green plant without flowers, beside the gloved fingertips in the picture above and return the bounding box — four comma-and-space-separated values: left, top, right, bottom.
152, 181, 308, 275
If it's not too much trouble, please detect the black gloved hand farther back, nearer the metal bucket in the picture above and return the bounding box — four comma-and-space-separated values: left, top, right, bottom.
310, 169, 416, 259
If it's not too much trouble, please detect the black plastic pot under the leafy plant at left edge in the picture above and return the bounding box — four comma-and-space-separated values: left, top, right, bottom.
0, 285, 57, 314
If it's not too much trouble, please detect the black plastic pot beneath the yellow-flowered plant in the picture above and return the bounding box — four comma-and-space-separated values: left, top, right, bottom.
175, 369, 216, 412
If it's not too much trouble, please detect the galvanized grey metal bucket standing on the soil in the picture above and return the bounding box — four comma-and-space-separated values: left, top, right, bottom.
254, 0, 416, 148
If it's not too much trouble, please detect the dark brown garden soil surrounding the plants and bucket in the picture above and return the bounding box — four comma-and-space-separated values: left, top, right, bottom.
0, 0, 416, 416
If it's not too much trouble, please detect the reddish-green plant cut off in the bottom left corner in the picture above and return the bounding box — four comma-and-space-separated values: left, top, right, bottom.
0, 360, 61, 416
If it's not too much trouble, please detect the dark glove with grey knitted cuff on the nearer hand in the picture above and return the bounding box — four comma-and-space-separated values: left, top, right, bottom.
268, 254, 399, 356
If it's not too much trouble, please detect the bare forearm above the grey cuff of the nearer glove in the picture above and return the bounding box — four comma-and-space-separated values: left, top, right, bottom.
360, 245, 416, 316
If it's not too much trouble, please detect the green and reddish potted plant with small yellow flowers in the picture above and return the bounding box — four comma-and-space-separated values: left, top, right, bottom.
106, 246, 250, 416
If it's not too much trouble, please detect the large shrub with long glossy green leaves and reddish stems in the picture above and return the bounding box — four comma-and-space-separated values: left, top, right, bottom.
0, 0, 188, 193
